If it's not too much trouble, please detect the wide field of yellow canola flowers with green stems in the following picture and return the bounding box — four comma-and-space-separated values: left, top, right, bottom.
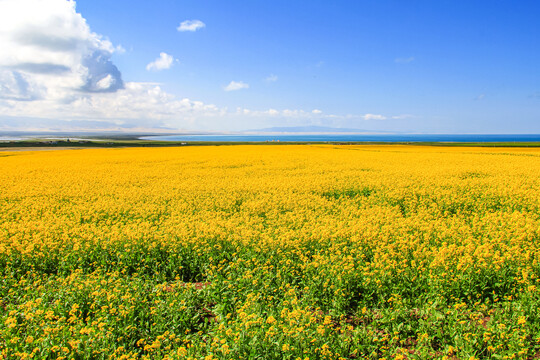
0, 145, 540, 360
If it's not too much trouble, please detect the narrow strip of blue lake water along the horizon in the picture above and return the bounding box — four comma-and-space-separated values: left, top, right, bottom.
141, 134, 540, 143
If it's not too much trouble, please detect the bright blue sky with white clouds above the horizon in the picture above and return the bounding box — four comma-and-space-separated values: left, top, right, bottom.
0, 0, 540, 134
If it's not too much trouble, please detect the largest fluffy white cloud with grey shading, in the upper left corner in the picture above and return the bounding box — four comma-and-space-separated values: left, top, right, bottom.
0, 0, 124, 101
